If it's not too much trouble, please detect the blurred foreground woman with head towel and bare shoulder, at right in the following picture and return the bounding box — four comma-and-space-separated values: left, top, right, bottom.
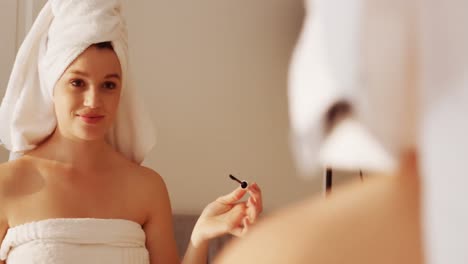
218, 0, 468, 264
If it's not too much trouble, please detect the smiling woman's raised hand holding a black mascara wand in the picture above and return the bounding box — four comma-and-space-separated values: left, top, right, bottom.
191, 183, 263, 247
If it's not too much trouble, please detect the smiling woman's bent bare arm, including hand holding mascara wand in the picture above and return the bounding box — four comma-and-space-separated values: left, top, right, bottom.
143, 168, 262, 264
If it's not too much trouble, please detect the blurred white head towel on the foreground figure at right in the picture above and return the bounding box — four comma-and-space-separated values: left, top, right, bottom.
289, 0, 417, 174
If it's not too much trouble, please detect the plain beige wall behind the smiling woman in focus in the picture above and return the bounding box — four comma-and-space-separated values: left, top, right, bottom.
0, 0, 360, 213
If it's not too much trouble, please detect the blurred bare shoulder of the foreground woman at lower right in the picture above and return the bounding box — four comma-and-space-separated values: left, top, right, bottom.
216, 177, 422, 264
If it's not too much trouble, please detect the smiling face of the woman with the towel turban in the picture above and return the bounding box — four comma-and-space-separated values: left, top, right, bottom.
54, 46, 122, 140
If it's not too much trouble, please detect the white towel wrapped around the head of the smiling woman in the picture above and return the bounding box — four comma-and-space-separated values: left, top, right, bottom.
0, 0, 155, 163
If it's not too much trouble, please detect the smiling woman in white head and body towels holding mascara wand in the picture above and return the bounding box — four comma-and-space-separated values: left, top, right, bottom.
0, 0, 262, 263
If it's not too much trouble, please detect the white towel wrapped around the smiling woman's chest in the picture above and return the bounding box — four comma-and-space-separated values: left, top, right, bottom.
0, 218, 149, 264
